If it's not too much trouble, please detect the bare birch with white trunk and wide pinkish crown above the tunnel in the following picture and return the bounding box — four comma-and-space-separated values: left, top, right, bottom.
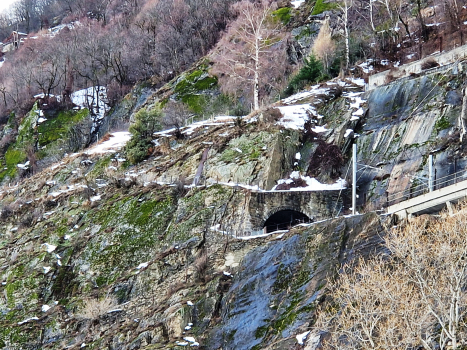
212, 0, 287, 110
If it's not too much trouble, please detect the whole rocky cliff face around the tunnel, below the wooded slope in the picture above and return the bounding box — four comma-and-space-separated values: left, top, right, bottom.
0, 58, 465, 349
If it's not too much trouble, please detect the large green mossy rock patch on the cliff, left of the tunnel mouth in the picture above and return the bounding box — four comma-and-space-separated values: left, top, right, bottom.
84, 196, 174, 286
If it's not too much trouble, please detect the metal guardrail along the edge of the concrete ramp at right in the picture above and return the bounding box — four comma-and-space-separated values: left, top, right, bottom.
386, 170, 467, 207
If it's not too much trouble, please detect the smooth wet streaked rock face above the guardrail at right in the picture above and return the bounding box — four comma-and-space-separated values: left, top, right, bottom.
357, 64, 466, 209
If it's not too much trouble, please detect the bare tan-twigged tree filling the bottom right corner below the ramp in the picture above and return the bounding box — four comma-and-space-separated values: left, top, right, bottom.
317, 204, 467, 350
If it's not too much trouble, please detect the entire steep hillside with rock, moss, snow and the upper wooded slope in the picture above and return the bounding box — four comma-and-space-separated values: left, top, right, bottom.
0, 0, 467, 350
